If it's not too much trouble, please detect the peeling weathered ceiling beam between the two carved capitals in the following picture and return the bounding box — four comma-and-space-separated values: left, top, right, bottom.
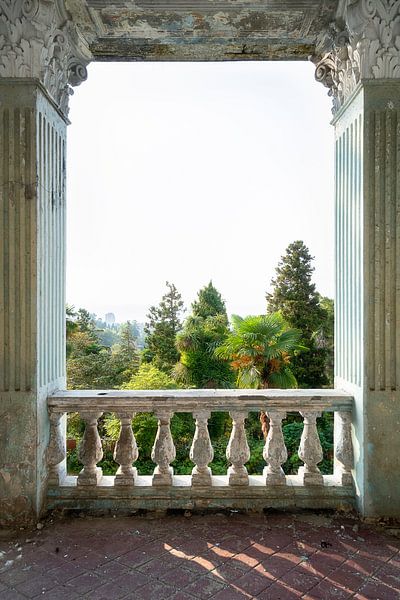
66, 0, 340, 61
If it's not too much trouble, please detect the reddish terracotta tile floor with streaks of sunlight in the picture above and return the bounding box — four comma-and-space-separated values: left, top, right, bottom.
0, 512, 400, 600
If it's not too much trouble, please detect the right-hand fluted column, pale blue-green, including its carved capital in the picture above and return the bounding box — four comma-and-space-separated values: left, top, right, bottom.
316, 0, 400, 517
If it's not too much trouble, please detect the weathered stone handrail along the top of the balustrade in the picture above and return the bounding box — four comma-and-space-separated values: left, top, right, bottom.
48, 389, 353, 412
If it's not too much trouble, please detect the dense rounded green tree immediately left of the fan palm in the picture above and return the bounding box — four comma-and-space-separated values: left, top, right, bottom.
175, 282, 234, 388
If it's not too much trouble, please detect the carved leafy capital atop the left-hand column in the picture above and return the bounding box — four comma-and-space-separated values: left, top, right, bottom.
0, 0, 91, 116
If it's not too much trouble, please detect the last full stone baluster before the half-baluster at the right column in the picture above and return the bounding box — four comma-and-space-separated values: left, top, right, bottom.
299, 411, 324, 485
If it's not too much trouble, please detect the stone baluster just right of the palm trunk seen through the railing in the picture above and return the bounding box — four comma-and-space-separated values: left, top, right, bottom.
263, 411, 287, 485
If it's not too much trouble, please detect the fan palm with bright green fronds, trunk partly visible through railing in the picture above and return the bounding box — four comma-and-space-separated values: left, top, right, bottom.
215, 312, 302, 436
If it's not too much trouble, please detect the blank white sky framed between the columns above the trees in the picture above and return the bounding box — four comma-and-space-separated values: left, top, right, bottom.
67, 62, 334, 322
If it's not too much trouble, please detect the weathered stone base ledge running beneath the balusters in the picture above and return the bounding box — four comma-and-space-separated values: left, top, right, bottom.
47, 475, 355, 512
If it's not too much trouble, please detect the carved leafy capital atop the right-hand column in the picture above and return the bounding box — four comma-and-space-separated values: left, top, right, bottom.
312, 0, 400, 113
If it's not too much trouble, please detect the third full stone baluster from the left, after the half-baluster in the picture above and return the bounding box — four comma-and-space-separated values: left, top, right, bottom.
151, 410, 176, 486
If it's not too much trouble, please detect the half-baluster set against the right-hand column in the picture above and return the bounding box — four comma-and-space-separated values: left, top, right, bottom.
334, 411, 354, 485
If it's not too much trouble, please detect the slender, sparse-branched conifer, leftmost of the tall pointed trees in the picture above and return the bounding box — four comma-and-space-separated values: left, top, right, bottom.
143, 281, 183, 373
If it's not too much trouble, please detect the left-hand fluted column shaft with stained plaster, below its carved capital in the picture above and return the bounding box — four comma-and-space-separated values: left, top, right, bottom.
0, 79, 66, 522
